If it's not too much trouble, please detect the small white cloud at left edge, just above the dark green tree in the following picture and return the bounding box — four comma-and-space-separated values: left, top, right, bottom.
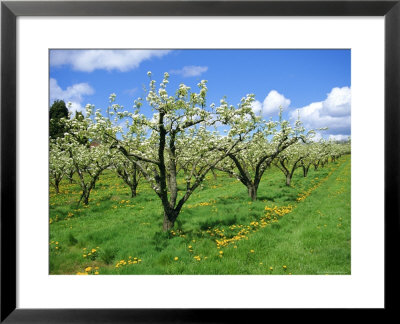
50, 78, 94, 112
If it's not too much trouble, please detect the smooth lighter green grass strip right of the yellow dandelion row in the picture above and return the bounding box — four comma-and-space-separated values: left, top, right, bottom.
231, 158, 351, 274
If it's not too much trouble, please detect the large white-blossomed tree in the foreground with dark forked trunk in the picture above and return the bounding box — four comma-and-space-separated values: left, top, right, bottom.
98, 72, 256, 231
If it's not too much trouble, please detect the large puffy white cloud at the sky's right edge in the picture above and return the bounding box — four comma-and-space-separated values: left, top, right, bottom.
290, 87, 351, 136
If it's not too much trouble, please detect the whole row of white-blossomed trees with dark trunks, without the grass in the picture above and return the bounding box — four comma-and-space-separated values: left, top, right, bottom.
50, 72, 349, 230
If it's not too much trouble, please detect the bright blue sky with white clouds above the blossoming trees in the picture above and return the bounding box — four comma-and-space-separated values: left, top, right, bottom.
50, 49, 351, 139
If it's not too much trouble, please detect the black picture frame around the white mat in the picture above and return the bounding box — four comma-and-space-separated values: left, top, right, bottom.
1, 0, 400, 323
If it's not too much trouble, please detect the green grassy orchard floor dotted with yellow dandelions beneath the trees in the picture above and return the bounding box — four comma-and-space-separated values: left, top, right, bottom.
49, 155, 351, 275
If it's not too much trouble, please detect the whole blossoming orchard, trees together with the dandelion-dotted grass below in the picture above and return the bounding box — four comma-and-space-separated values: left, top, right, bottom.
49, 72, 351, 274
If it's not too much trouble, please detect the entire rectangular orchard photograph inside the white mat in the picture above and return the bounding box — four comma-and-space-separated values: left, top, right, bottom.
49, 49, 351, 275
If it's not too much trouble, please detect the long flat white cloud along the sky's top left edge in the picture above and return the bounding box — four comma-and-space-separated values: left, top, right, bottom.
50, 50, 170, 72
